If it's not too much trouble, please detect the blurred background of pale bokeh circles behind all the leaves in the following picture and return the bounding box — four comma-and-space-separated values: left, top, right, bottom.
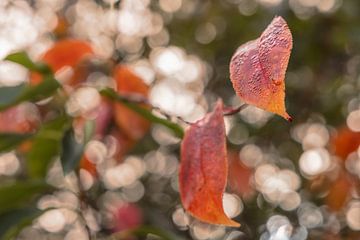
0, 0, 360, 240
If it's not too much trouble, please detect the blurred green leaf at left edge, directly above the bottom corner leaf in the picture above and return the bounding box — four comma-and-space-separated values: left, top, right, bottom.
0, 180, 51, 213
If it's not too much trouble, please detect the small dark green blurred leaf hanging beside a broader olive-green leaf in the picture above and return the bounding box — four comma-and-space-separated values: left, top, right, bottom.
60, 128, 85, 175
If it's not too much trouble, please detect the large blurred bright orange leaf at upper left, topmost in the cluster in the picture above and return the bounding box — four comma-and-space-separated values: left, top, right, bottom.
30, 39, 93, 85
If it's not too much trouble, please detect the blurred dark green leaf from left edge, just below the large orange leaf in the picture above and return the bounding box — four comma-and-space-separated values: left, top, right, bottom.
0, 75, 60, 110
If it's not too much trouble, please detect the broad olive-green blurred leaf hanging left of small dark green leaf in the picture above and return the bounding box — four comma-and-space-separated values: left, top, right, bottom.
26, 116, 70, 178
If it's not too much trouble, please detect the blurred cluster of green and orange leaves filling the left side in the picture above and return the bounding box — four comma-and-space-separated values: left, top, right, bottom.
0, 39, 183, 239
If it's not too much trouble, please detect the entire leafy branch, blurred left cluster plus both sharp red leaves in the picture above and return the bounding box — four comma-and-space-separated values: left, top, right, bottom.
0, 17, 292, 238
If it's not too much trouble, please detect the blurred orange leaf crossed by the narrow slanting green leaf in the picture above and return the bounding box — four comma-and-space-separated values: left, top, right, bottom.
114, 66, 150, 140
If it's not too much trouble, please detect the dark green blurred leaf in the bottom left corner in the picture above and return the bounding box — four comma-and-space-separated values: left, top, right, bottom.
0, 208, 42, 240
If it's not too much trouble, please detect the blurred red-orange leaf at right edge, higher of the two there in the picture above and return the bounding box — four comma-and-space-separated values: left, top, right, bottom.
330, 127, 360, 160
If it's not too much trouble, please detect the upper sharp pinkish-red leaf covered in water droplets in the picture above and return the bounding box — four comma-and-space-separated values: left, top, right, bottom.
230, 17, 292, 121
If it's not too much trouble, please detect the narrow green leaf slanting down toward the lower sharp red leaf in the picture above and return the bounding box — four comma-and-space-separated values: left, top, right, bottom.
100, 88, 184, 138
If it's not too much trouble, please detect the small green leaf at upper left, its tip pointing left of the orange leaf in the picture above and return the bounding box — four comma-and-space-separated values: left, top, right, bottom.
5, 52, 52, 74
